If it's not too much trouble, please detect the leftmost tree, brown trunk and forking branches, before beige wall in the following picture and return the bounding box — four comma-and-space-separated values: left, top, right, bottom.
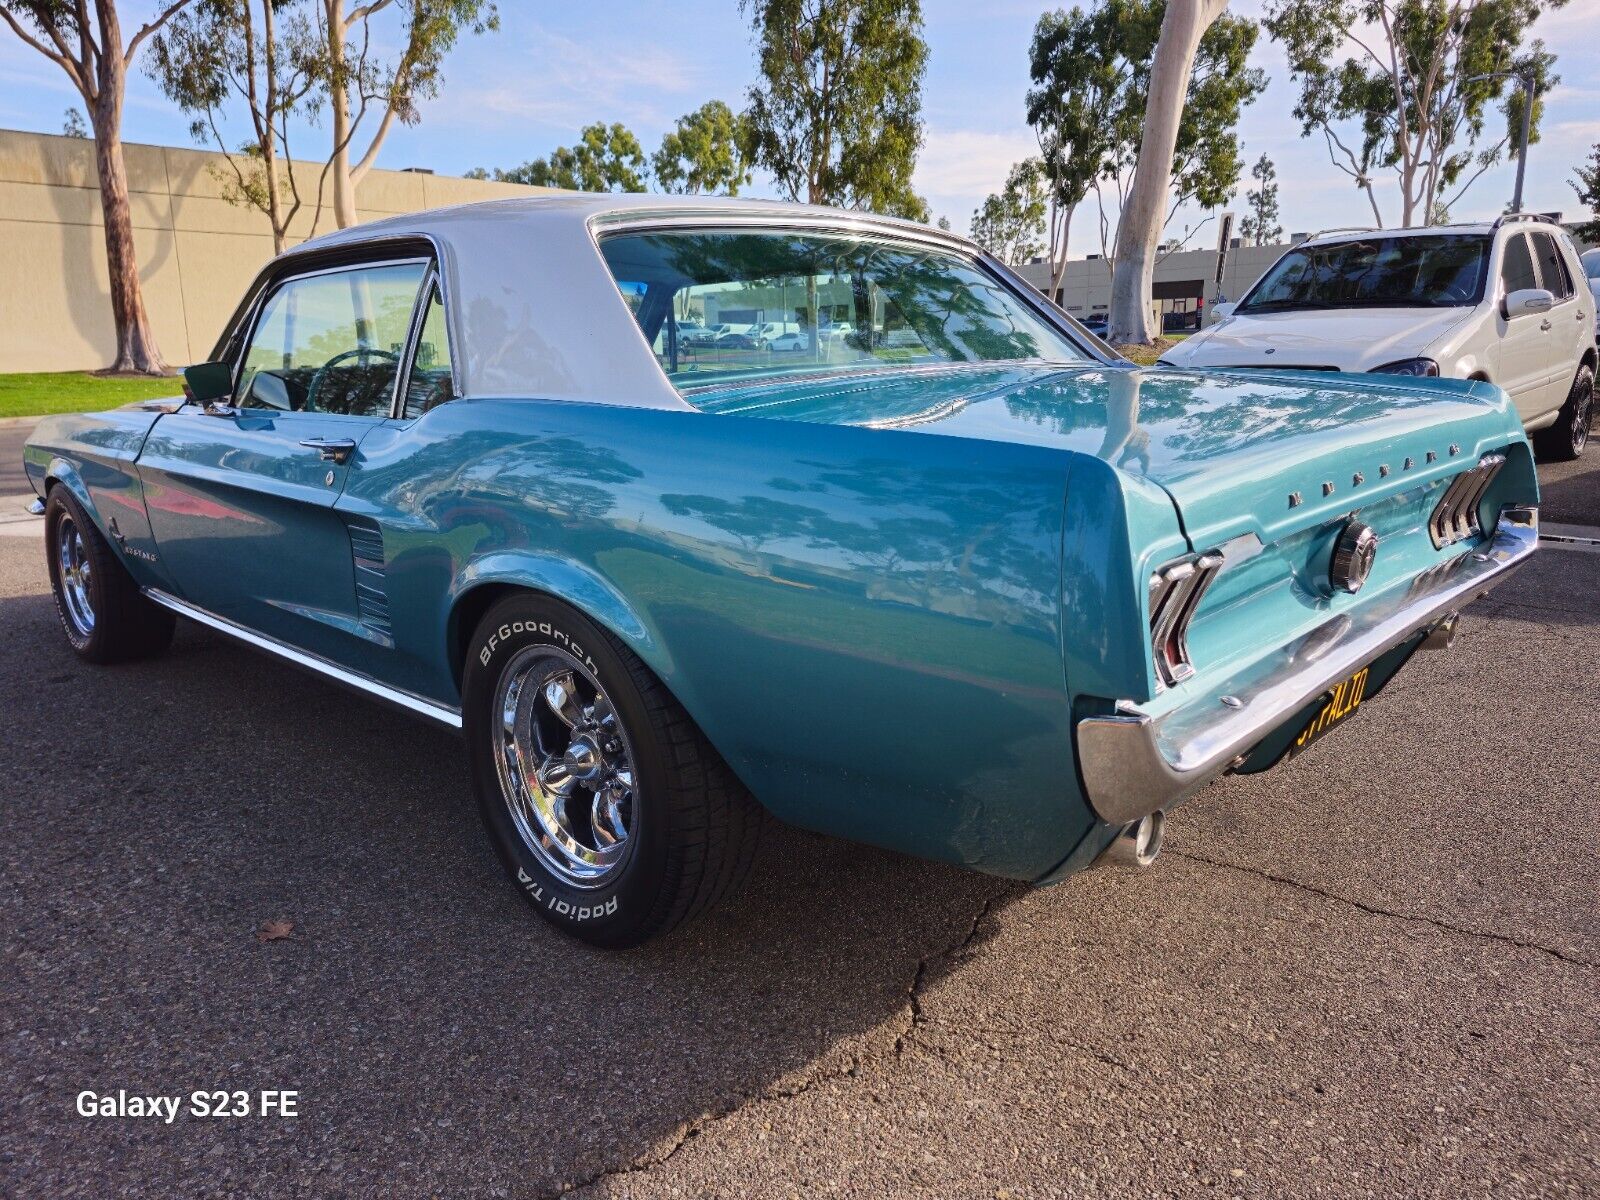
0, 0, 200, 374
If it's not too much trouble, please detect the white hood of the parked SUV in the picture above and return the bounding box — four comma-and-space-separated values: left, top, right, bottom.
1163, 307, 1472, 371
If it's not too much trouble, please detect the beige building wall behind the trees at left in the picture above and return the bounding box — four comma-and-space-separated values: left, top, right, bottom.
0, 130, 563, 373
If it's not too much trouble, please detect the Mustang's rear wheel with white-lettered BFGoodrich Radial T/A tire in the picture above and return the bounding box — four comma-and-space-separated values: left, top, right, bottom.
462, 594, 763, 947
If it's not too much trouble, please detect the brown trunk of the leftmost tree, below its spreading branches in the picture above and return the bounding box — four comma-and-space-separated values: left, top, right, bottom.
90, 37, 166, 374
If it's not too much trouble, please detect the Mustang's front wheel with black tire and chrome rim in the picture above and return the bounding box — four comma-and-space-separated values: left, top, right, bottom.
45, 486, 178, 662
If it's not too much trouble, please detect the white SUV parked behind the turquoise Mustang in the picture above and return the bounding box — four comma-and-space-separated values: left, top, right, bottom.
1162, 214, 1595, 459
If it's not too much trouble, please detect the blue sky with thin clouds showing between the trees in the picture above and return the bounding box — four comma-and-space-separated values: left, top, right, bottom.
0, 0, 1600, 256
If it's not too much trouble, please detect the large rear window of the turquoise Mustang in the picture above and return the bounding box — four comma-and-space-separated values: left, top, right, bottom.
600, 230, 1088, 392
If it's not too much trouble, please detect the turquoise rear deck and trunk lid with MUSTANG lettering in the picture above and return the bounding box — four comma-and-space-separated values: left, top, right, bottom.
690, 365, 1525, 542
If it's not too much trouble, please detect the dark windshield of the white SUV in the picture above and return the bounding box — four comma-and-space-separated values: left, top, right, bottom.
1238, 234, 1490, 312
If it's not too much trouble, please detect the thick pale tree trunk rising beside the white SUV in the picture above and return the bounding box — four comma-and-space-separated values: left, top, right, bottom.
1107, 0, 1227, 346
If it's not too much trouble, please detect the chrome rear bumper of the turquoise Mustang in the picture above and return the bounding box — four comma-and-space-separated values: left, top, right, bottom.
1077, 506, 1539, 826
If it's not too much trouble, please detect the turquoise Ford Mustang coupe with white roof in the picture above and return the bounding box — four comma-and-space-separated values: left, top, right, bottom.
26, 195, 1538, 946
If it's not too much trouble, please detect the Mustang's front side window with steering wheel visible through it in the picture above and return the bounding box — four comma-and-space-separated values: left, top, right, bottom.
234, 262, 427, 418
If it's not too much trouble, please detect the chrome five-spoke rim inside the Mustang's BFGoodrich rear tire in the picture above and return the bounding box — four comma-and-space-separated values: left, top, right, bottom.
493, 646, 638, 888
